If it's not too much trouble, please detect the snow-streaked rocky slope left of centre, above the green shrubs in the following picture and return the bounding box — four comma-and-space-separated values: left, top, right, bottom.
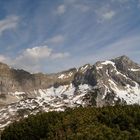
0, 84, 91, 129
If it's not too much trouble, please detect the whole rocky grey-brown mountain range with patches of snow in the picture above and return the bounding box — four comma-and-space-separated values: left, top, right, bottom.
0, 56, 140, 130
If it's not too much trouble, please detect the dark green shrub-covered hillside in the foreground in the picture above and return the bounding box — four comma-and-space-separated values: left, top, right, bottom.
1, 105, 140, 140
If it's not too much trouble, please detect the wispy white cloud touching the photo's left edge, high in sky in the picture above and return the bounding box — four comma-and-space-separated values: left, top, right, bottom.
0, 15, 19, 35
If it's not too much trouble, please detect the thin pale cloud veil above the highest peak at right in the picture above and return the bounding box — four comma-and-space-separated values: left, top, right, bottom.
81, 35, 140, 63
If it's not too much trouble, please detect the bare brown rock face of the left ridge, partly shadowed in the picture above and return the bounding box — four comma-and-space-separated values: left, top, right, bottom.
0, 63, 76, 94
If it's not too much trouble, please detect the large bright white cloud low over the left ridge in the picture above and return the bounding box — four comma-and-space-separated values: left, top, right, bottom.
0, 45, 69, 72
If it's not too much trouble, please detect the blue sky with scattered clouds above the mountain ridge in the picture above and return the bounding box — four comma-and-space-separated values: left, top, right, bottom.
0, 0, 140, 73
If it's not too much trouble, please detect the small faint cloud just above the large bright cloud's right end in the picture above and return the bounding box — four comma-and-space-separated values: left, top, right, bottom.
46, 35, 65, 45
